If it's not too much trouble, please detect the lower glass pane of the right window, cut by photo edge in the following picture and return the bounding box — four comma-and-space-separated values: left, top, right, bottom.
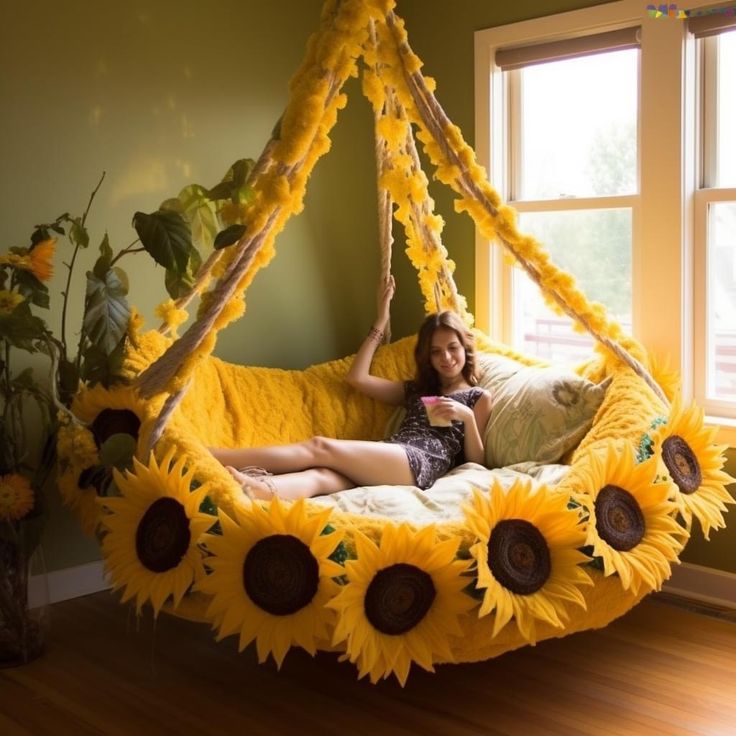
707, 202, 736, 401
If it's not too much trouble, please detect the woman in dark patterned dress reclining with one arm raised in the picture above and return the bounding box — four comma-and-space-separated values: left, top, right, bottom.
211, 276, 491, 499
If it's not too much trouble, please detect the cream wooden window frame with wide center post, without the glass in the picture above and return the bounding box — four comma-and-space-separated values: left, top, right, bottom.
475, 0, 736, 446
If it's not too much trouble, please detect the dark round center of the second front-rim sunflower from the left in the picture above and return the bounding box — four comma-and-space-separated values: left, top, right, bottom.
243, 534, 319, 616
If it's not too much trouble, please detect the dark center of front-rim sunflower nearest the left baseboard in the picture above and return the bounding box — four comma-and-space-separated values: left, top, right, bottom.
135, 498, 192, 572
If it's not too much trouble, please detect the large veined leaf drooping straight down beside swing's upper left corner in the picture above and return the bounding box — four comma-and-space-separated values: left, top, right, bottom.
84, 266, 130, 355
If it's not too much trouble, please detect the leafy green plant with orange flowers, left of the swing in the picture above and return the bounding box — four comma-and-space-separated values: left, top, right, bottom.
0, 154, 255, 524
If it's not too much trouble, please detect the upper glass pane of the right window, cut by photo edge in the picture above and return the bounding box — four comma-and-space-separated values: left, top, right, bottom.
716, 31, 736, 187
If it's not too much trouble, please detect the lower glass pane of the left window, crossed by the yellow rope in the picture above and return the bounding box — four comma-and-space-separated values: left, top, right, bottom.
513, 209, 632, 362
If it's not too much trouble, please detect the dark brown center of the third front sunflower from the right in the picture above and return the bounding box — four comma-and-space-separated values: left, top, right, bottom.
488, 519, 552, 595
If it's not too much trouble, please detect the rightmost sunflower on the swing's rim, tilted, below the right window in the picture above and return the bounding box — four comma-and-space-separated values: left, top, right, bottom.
651, 398, 734, 539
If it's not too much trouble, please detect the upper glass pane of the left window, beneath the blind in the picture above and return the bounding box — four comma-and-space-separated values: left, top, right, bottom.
515, 49, 639, 199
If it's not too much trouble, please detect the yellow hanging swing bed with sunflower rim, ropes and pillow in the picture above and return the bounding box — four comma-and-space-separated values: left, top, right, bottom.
58, 0, 733, 684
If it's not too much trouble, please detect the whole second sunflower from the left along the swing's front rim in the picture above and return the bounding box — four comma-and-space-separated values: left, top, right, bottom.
197, 498, 344, 668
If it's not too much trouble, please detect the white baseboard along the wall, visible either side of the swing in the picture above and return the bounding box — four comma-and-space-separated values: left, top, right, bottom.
33, 560, 736, 608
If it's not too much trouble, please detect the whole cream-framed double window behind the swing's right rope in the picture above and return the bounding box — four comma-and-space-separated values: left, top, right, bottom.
475, 0, 736, 446
